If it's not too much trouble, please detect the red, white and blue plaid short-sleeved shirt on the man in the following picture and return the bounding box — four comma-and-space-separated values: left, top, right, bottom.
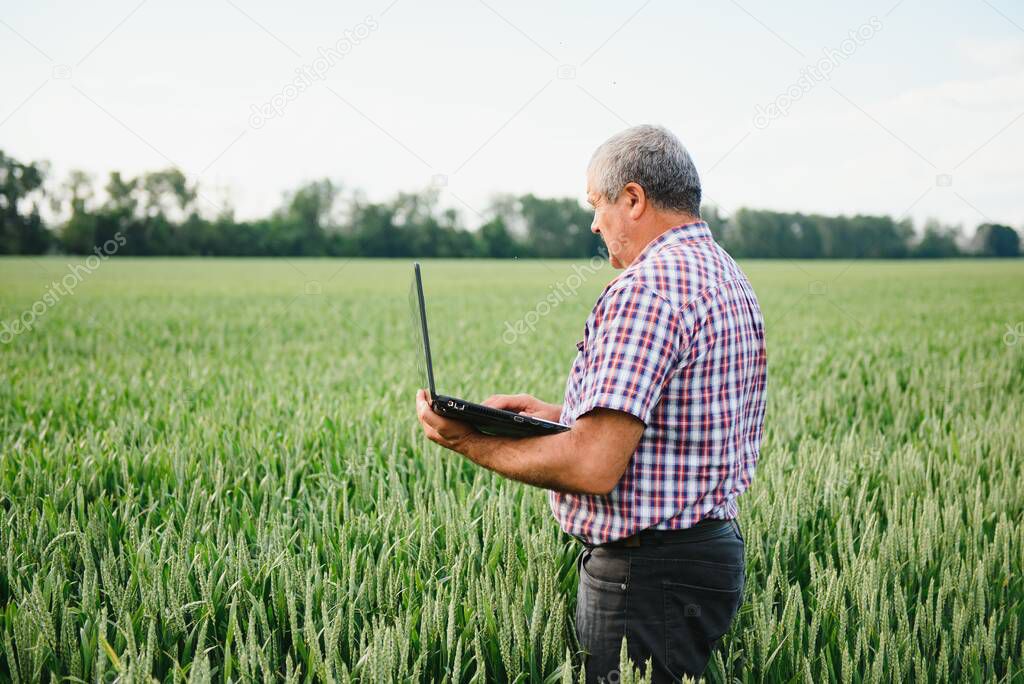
549, 221, 767, 544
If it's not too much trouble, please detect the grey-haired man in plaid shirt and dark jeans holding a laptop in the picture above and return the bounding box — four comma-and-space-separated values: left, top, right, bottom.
417, 126, 766, 682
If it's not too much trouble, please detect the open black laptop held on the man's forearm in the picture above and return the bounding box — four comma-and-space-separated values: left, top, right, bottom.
410, 263, 569, 437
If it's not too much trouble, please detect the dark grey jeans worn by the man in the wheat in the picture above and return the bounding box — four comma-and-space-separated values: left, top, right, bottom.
575, 520, 744, 682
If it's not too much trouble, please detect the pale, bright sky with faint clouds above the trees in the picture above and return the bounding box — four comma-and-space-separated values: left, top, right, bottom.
0, 0, 1024, 231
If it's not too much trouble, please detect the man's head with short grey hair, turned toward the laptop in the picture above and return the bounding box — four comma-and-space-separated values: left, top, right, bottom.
587, 125, 700, 268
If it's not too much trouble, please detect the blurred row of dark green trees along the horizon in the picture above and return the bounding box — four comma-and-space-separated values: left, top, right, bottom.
0, 151, 1020, 259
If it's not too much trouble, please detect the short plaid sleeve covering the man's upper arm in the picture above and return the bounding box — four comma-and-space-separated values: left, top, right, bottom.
574, 284, 682, 424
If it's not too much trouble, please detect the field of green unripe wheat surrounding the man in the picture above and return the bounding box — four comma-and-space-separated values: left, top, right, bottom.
0, 258, 1024, 682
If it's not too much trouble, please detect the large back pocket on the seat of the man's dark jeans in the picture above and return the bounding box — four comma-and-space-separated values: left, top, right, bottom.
662, 571, 743, 677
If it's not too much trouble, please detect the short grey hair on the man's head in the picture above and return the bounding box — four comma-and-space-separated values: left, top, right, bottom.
587, 124, 700, 217
